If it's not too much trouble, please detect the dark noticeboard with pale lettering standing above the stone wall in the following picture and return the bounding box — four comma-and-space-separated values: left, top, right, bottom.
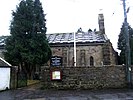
50, 56, 62, 67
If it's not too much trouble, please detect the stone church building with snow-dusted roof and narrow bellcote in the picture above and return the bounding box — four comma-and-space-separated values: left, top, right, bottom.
47, 14, 116, 67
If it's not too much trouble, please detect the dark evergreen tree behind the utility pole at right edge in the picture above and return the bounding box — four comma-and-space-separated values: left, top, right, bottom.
118, 23, 133, 64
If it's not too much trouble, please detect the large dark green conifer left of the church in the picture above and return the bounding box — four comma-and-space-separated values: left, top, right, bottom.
4, 0, 51, 77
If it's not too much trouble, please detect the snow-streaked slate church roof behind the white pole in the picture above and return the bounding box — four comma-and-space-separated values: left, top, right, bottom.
47, 31, 108, 43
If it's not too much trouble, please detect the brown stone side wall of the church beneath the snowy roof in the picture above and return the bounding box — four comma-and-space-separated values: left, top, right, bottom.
51, 43, 116, 67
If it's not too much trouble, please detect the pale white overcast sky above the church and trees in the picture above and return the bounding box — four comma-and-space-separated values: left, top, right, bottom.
0, 0, 133, 51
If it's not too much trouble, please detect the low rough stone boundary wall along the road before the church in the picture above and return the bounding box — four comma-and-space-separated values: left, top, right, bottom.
41, 65, 130, 89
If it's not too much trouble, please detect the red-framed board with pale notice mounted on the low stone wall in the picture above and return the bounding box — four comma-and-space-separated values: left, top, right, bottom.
51, 70, 62, 80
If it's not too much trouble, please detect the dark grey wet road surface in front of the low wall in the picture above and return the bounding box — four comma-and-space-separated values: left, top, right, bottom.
0, 85, 133, 100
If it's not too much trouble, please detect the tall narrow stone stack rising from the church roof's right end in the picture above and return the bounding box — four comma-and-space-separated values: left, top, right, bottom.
98, 13, 105, 34
